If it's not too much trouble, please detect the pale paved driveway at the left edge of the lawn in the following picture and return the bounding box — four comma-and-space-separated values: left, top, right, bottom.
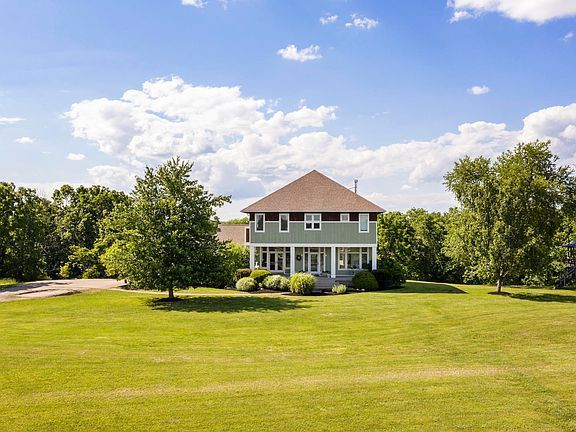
0, 279, 125, 302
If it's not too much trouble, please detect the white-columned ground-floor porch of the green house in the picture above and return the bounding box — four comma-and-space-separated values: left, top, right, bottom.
250, 244, 377, 279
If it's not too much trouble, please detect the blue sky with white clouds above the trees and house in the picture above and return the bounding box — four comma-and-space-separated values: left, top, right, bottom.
0, 0, 576, 219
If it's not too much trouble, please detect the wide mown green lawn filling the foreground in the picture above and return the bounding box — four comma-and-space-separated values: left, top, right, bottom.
0, 282, 576, 432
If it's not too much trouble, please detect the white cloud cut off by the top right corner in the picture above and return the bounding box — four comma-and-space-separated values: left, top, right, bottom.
448, 0, 576, 24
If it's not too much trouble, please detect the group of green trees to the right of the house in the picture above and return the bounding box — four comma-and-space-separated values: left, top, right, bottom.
378, 142, 576, 291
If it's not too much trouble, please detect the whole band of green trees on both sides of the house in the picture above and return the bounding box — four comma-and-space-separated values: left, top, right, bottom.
0, 142, 576, 296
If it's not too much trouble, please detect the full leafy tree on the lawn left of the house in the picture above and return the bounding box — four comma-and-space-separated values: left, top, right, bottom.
102, 158, 230, 299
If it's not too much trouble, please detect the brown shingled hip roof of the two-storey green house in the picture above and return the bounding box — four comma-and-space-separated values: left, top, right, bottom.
242, 170, 384, 213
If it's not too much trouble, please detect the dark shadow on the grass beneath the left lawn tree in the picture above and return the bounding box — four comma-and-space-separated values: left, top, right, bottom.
146, 296, 309, 313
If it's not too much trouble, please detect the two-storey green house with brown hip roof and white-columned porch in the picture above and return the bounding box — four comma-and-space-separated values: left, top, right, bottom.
242, 171, 384, 278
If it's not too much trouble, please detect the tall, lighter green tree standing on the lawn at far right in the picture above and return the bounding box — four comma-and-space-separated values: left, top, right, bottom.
445, 141, 574, 293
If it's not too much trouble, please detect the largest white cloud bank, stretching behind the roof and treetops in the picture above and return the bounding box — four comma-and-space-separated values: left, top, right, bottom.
65, 77, 576, 217
